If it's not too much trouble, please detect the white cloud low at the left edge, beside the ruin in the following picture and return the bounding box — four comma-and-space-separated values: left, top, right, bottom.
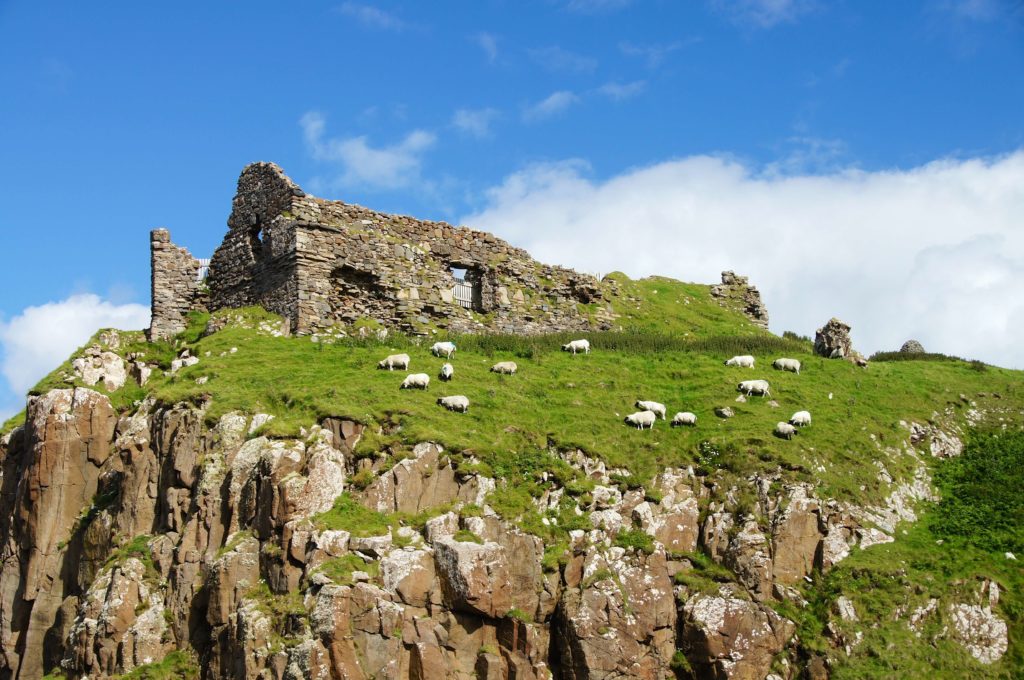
0, 293, 150, 394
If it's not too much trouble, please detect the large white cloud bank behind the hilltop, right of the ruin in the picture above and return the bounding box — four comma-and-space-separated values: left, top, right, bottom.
460, 151, 1024, 368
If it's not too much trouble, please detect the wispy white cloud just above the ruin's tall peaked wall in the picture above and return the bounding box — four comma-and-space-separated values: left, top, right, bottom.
299, 112, 437, 188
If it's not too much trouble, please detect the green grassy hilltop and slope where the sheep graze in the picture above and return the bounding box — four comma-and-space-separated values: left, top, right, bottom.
5, 275, 1024, 677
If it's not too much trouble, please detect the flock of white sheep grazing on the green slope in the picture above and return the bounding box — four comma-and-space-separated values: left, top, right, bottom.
377, 340, 811, 439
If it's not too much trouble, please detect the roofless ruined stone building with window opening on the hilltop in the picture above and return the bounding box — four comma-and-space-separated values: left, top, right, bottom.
151, 163, 612, 338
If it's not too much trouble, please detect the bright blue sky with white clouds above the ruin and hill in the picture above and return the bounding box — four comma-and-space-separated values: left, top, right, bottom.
0, 0, 1024, 419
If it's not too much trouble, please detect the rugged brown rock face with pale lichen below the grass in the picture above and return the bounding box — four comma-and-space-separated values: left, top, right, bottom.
0, 388, 983, 680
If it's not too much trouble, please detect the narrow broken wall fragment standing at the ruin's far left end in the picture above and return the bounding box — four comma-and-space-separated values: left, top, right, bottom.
148, 229, 207, 340
